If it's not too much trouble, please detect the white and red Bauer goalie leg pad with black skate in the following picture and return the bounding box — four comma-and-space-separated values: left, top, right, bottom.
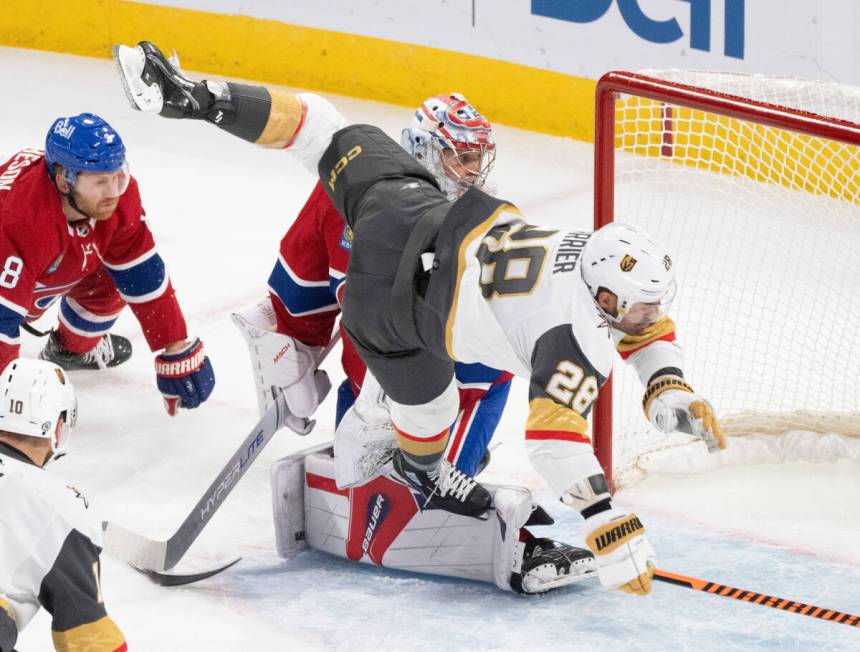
271, 445, 597, 593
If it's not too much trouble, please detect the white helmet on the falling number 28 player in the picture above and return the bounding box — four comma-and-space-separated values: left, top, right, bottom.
581, 222, 676, 323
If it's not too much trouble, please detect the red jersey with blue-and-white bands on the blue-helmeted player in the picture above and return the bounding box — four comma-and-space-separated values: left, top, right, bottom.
0, 149, 187, 365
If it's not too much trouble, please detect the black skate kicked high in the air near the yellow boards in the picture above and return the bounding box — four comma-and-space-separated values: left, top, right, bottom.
113, 41, 235, 124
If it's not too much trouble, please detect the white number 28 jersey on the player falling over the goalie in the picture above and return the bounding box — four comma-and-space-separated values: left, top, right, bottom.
437, 197, 682, 494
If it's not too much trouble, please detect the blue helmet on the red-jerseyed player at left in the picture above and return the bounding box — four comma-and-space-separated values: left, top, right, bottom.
45, 113, 125, 184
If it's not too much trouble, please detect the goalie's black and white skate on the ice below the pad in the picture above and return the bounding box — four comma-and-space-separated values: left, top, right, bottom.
511, 537, 597, 593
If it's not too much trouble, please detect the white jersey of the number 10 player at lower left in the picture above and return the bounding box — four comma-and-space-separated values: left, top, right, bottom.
0, 443, 126, 652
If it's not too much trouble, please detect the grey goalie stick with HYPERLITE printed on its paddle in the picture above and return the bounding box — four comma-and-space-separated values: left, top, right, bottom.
102, 330, 340, 585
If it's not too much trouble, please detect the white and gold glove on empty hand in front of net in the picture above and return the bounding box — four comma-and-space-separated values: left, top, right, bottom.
642, 376, 726, 453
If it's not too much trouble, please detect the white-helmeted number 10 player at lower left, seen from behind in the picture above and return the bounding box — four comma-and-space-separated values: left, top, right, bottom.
0, 358, 127, 652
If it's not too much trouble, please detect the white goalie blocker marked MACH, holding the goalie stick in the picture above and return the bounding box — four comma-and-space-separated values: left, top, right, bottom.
231, 297, 331, 426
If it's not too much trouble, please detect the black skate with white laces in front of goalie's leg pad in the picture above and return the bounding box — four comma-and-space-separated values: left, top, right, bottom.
392, 450, 492, 518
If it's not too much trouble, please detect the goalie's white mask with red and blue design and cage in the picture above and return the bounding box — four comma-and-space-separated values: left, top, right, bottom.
400, 93, 496, 199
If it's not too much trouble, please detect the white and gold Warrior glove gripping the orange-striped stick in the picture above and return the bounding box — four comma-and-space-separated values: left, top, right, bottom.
585, 509, 654, 595
